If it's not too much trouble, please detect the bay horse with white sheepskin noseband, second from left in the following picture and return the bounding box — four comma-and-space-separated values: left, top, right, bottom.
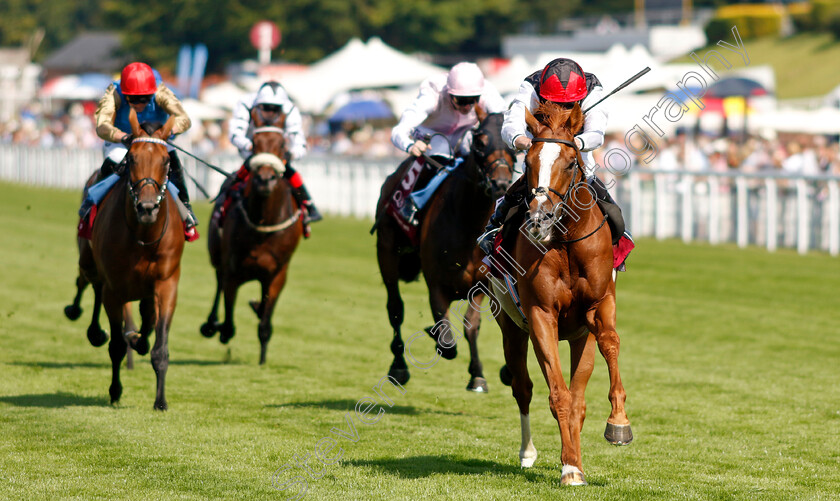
201, 108, 303, 365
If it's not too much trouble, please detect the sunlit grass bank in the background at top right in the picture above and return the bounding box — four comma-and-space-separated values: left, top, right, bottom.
678, 33, 840, 99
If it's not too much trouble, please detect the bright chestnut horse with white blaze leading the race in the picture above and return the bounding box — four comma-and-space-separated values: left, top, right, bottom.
496, 102, 633, 485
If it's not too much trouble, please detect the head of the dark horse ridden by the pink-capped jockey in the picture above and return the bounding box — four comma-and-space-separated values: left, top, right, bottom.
470, 106, 516, 200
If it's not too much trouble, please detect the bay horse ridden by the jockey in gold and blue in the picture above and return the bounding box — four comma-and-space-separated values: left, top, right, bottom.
77, 110, 184, 411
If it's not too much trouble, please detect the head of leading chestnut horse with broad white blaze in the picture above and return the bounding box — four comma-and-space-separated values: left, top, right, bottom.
525, 101, 586, 243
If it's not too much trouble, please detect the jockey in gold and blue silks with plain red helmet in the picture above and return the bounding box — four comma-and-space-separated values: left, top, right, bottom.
80, 62, 198, 241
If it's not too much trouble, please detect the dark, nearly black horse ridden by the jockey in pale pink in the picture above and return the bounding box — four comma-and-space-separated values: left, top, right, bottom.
376, 107, 516, 392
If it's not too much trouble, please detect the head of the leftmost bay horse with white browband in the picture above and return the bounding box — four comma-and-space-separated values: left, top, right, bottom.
126, 109, 175, 224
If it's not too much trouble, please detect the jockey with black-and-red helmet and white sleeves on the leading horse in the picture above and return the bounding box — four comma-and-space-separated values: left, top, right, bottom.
478, 58, 626, 254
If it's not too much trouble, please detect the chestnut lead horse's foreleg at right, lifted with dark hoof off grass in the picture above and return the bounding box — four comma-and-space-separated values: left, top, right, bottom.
587, 295, 633, 445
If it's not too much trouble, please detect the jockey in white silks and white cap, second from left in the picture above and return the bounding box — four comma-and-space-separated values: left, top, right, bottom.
213, 81, 323, 238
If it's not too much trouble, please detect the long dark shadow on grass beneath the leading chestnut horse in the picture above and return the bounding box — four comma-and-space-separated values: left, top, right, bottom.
341, 456, 604, 487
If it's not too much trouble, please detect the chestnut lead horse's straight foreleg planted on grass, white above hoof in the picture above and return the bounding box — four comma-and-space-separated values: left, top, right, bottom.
528, 306, 586, 485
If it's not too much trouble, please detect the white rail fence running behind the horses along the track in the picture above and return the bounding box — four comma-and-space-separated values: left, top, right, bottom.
0, 144, 840, 256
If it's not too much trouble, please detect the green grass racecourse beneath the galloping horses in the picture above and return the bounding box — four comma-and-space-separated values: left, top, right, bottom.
0, 184, 840, 501
